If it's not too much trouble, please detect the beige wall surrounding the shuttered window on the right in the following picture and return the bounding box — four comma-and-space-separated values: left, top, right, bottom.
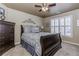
43, 9, 79, 45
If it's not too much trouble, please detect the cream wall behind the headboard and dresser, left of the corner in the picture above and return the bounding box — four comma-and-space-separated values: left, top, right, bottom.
0, 4, 42, 44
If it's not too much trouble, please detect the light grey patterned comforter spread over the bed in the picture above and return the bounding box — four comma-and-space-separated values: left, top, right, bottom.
22, 32, 51, 56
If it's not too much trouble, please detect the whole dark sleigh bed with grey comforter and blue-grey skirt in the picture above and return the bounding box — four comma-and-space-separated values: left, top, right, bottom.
21, 26, 62, 56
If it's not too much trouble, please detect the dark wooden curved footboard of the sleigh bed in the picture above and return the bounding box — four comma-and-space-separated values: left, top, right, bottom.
40, 33, 62, 56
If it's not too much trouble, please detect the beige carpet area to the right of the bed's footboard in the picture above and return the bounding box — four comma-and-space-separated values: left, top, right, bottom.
55, 43, 79, 56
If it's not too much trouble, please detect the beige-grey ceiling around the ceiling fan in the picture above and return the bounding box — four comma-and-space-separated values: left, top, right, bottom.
5, 3, 79, 18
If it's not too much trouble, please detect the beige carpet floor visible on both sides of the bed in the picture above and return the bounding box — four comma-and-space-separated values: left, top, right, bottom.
2, 43, 79, 56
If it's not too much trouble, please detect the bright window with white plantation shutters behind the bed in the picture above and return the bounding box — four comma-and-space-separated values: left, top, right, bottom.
51, 16, 72, 36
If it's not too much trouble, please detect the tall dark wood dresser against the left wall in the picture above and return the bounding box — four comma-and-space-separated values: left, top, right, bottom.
0, 20, 15, 55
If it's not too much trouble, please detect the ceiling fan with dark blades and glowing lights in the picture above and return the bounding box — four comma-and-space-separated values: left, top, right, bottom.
35, 3, 56, 12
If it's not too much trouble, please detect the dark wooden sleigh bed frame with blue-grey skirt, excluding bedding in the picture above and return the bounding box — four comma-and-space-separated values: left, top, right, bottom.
21, 25, 62, 56
